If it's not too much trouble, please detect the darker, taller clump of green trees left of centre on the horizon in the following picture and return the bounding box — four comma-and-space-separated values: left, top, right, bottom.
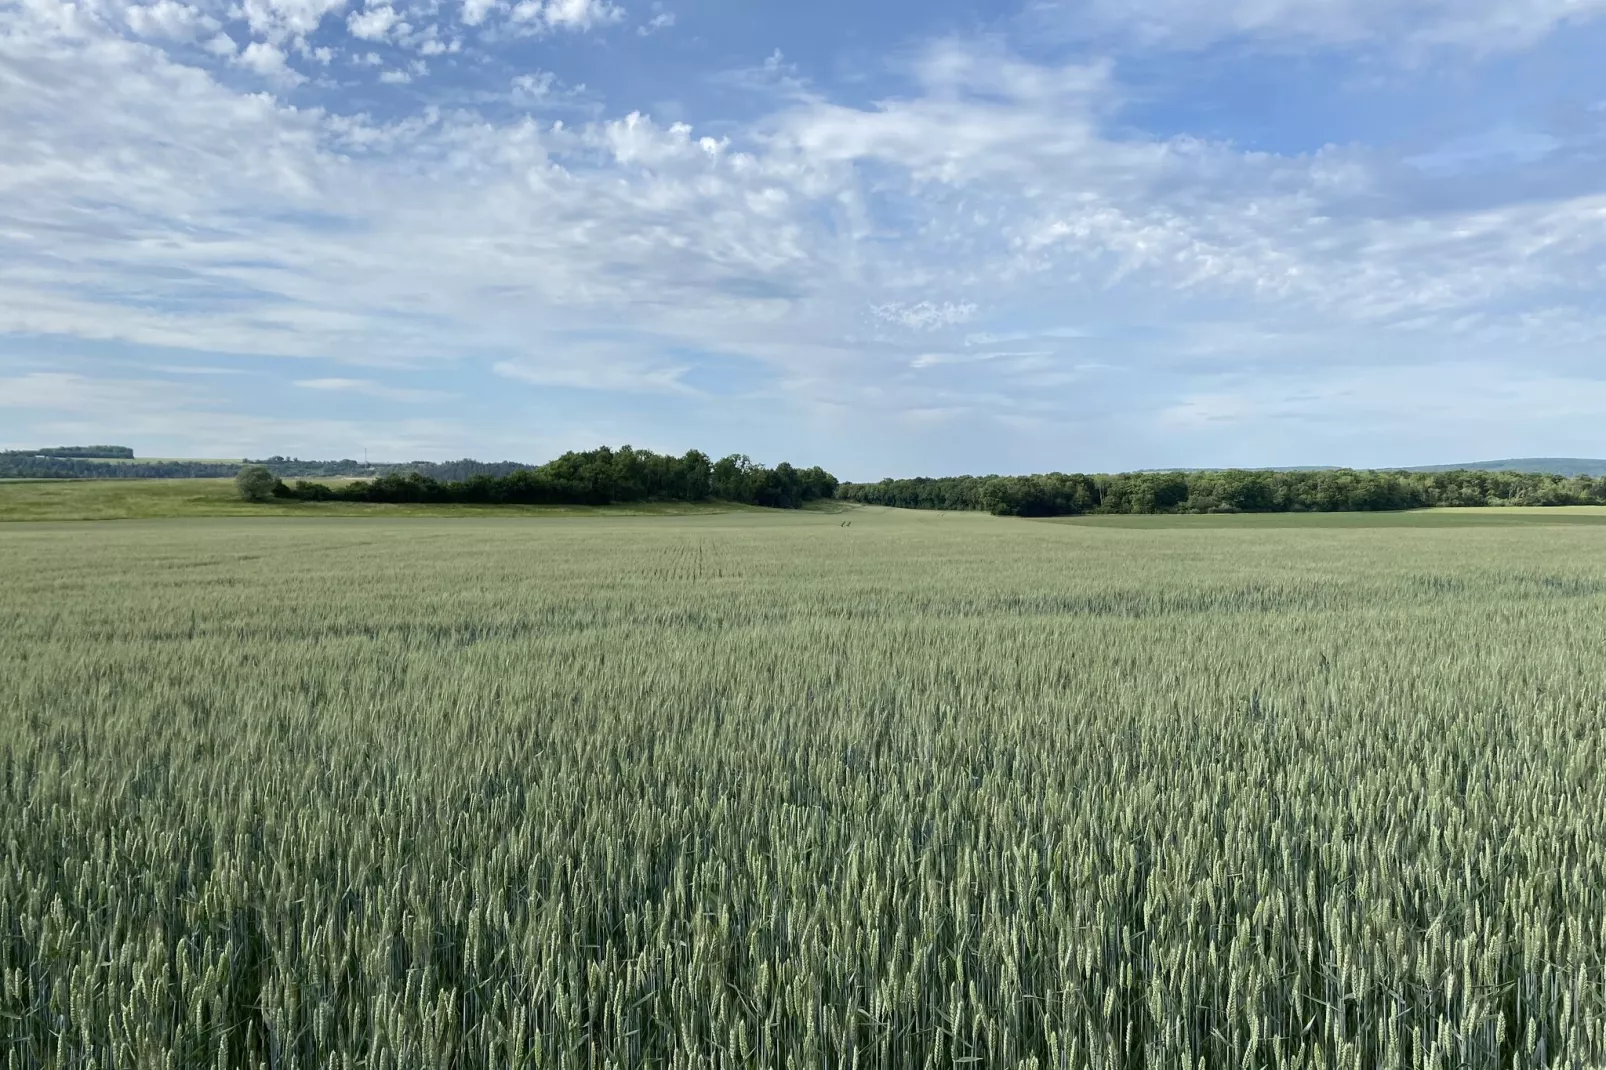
271, 445, 837, 509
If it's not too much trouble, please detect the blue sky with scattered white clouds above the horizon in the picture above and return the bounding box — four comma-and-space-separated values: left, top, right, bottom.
0, 0, 1606, 479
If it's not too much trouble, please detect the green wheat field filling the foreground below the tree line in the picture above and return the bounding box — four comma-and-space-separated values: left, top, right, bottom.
0, 509, 1606, 1070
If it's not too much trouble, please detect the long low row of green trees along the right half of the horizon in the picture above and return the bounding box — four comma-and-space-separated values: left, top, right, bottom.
837, 469, 1606, 516
